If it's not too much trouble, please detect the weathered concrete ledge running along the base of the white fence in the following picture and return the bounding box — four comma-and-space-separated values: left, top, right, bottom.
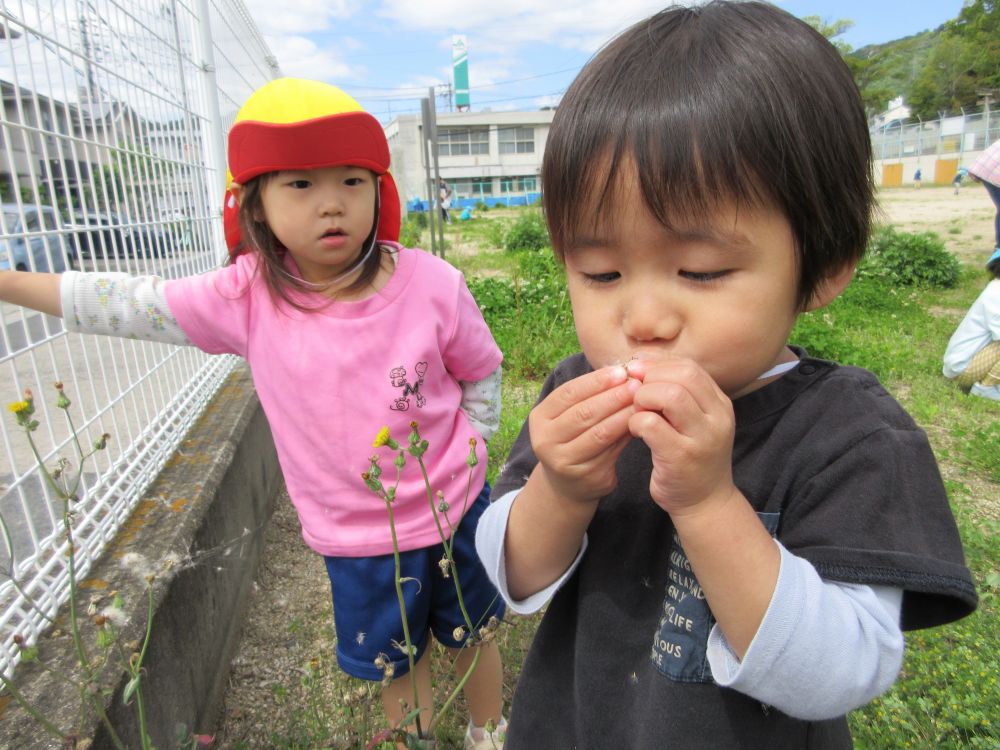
0, 365, 282, 750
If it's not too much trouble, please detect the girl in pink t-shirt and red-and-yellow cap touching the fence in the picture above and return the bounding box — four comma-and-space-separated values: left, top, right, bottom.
0, 79, 505, 748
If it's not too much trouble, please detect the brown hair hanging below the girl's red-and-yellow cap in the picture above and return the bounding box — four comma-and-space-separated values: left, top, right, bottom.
232, 172, 382, 310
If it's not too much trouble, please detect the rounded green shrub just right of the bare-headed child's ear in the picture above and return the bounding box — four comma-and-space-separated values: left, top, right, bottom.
858, 226, 961, 288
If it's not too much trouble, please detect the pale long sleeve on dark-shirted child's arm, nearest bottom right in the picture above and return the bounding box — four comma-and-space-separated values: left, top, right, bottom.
708, 542, 904, 721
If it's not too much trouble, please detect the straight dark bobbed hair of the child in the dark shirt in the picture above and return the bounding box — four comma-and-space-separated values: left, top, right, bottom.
542, 0, 874, 305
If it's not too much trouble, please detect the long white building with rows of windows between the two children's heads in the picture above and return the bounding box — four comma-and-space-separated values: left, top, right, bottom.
385, 110, 555, 210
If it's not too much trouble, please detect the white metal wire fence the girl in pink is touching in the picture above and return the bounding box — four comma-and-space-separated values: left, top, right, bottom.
0, 0, 278, 672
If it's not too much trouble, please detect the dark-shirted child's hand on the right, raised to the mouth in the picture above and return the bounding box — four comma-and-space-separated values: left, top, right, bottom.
628, 360, 736, 514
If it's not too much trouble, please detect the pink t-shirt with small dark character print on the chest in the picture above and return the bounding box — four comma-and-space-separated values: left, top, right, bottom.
165, 245, 503, 557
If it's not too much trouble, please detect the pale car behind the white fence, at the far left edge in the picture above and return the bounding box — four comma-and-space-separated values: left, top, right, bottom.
0, 203, 66, 273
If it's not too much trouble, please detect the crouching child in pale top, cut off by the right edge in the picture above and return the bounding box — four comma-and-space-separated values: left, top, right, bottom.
944, 250, 1000, 401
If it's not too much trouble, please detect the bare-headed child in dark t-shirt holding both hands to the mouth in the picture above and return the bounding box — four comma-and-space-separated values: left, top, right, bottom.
476, 2, 976, 750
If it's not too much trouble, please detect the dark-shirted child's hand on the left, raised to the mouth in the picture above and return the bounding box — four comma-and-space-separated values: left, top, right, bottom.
528, 366, 640, 501
